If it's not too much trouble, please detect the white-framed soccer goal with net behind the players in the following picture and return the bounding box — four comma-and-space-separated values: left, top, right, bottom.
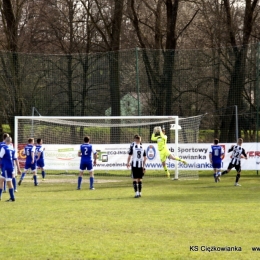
15, 116, 202, 179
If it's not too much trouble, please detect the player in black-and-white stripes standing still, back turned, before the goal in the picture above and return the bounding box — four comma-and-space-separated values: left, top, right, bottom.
127, 135, 146, 198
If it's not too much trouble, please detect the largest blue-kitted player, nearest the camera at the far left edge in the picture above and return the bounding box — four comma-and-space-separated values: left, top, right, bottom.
0, 137, 19, 202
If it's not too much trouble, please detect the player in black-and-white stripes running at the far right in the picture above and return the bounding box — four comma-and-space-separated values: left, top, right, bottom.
222, 138, 247, 186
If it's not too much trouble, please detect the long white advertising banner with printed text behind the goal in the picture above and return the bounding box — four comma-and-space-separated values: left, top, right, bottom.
18, 143, 260, 170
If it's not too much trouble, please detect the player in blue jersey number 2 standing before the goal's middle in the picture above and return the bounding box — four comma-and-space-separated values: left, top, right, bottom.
77, 136, 97, 190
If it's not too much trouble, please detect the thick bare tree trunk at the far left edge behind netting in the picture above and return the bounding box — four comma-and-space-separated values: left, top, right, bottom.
0, 0, 26, 139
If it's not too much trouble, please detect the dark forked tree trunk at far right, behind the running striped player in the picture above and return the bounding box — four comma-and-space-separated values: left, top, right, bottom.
220, 0, 259, 142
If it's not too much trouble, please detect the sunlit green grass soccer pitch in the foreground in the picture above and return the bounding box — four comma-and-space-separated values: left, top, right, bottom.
0, 171, 260, 260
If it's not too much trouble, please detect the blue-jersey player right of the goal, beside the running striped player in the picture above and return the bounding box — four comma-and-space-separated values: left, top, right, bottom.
209, 138, 224, 182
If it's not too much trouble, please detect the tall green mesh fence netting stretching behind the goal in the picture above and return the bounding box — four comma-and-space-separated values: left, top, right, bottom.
0, 44, 260, 142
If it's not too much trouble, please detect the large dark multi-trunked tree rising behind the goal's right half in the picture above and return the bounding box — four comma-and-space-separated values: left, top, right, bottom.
130, 0, 197, 115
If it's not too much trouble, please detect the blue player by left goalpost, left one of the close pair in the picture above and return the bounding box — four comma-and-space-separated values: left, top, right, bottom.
18, 138, 38, 186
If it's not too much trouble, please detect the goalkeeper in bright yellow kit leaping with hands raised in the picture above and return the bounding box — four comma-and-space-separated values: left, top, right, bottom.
151, 126, 187, 178
